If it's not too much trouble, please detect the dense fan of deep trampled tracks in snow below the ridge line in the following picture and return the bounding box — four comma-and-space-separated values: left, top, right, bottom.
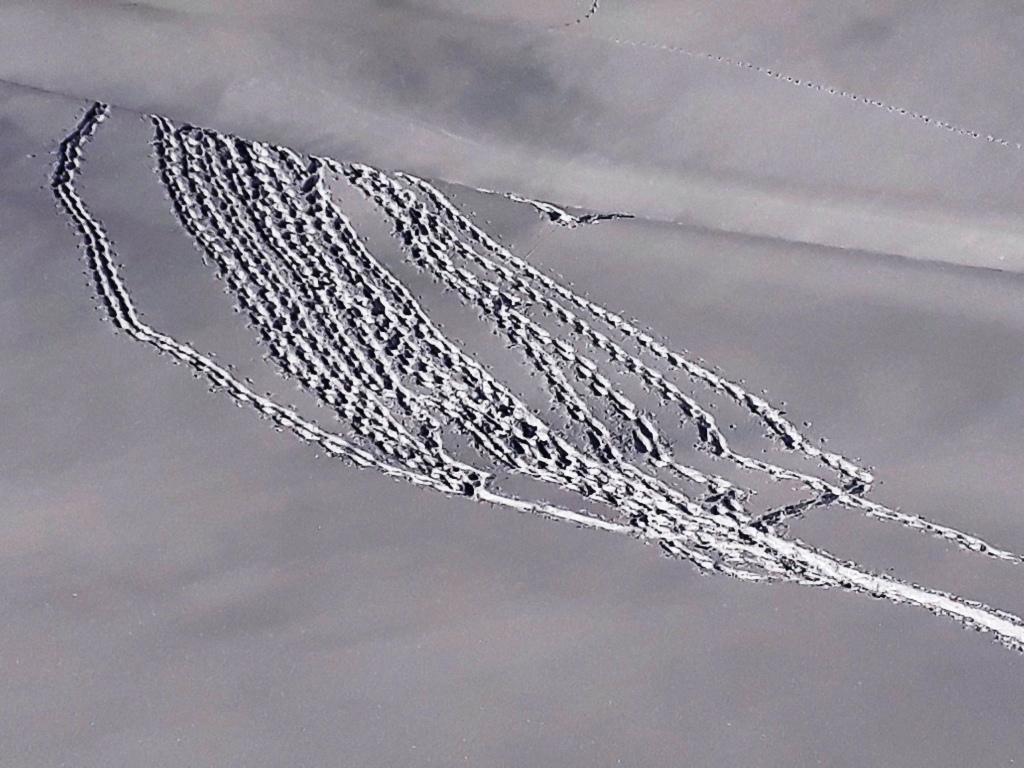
51, 102, 1024, 650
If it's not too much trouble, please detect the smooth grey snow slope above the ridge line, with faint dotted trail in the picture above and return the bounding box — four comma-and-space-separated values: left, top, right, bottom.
6, 0, 1024, 270
